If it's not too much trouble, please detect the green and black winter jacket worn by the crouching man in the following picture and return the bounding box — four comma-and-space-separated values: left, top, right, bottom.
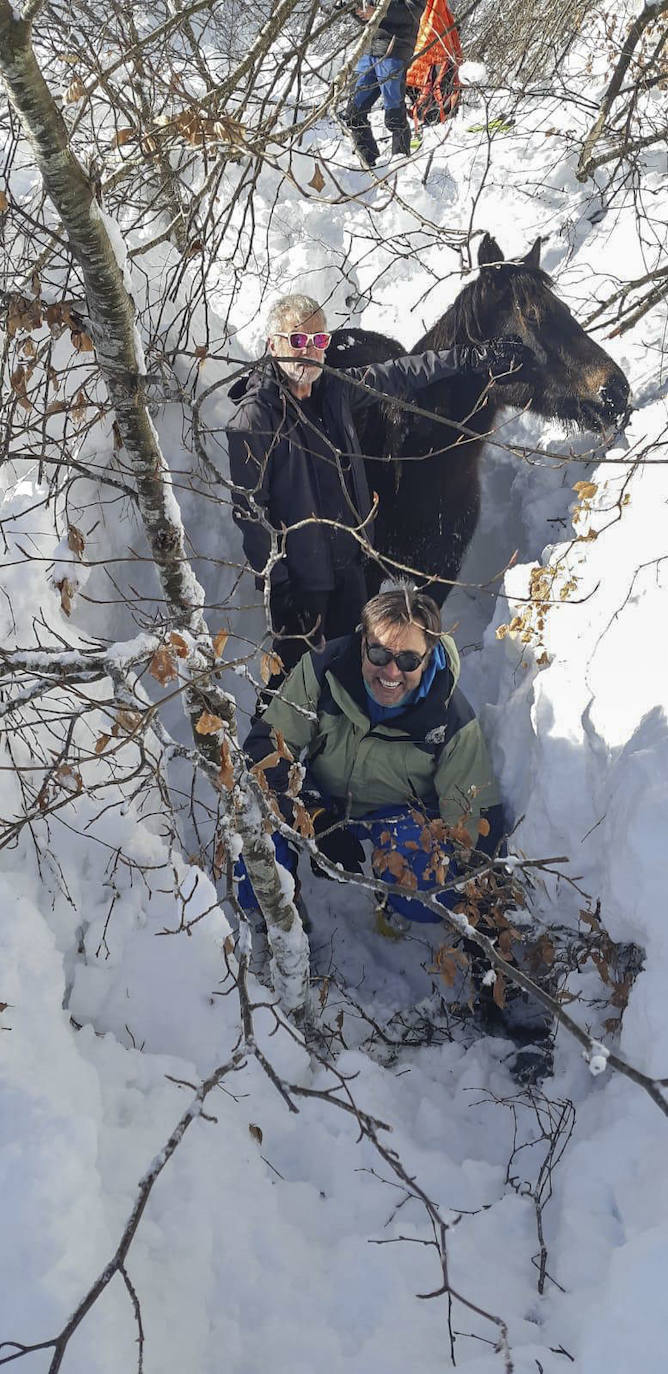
245, 633, 503, 849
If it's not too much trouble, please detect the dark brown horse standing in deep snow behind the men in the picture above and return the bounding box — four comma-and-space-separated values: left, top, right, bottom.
327, 234, 628, 605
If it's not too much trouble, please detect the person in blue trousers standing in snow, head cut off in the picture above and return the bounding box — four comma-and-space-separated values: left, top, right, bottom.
342, 0, 422, 168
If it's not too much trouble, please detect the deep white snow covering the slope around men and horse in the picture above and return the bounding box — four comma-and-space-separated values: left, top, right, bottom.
0, 10, 668, 1374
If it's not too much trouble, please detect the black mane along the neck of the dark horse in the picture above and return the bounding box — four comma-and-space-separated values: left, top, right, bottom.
412, 262, 553, 353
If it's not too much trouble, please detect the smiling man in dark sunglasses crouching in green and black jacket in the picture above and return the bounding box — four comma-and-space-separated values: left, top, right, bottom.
239, 584, 503, 923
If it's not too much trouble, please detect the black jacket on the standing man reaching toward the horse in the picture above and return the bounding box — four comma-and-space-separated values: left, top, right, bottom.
227, 348, 478, 591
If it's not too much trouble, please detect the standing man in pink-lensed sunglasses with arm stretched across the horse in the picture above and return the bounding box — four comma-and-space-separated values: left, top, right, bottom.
227, 294, 536, 691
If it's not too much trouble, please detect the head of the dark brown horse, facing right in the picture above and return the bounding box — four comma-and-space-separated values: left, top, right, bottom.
455, 234, 630, 431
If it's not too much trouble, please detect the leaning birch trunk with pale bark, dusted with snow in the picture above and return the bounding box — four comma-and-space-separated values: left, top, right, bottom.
0, 0, 309, 1011
